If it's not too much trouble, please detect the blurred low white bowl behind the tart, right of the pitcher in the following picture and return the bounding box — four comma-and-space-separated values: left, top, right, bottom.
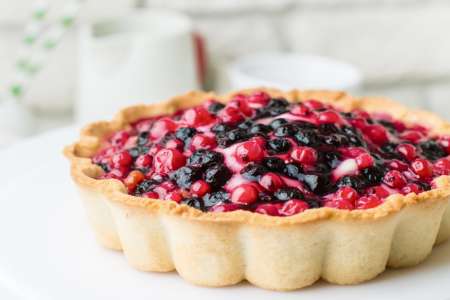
229, 53, 362, 91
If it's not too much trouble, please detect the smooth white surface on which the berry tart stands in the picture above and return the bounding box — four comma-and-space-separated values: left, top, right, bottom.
0, 129, 450, 300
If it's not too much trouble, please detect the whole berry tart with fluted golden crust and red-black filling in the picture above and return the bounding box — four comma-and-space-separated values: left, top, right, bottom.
65, 89, 450, 290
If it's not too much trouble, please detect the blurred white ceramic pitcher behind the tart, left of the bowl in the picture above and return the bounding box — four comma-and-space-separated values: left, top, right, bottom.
76, 10, 199, 122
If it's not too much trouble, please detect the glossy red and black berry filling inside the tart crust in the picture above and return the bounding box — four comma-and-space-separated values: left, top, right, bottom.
92, 92, 450, 216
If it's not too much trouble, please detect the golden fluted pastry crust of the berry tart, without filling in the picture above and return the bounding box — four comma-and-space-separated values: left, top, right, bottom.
64, 89, 450, 290
